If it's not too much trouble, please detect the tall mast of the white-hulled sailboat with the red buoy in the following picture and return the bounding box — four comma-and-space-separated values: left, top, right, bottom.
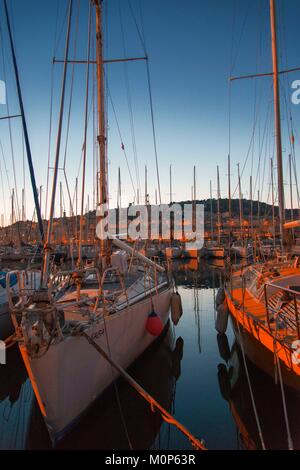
93, 0, 108, 257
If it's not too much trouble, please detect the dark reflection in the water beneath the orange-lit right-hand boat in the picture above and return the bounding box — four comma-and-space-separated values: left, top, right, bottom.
217, 335, 300, 450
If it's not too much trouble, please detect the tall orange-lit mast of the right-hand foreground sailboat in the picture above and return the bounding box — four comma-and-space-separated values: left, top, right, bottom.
270, 0, 285, 246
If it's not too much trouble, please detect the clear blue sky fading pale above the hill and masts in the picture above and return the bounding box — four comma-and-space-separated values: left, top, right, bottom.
0, 0, 300, 224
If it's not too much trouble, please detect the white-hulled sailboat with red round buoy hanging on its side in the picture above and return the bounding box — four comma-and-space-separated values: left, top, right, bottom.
8, 0, 173, 442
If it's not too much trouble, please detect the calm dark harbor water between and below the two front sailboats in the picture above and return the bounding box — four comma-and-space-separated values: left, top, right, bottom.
0, 260, 300, 450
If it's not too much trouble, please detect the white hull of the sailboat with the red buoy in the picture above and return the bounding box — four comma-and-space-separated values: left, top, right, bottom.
20, 288, 172, 441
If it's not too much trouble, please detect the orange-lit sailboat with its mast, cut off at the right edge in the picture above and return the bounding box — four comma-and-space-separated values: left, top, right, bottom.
220, 0, 300, 389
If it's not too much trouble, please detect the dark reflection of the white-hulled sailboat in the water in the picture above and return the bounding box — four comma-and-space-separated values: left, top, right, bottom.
26, 327, 184, 450
